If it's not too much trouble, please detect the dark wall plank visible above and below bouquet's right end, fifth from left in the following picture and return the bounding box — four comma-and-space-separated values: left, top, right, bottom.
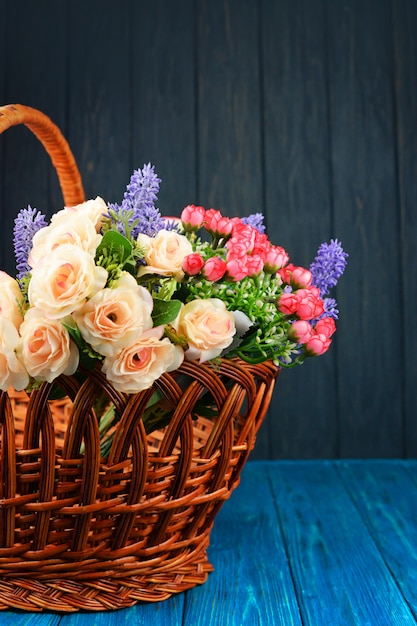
262, 0, 337, 457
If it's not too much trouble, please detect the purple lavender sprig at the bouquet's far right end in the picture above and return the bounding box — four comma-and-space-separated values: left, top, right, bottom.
310, 239, 348, 296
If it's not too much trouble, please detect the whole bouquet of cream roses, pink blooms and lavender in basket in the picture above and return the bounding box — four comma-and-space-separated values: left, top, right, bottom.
0, 164, 347, 434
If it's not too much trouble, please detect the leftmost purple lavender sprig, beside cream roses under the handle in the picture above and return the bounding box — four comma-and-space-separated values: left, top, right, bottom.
13, 204, 48, 278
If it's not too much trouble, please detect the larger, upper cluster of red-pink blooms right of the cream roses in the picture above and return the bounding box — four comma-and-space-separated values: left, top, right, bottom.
181, 205, 290, 281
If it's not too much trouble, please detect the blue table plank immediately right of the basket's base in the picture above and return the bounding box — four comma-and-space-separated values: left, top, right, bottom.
184, 462, 301, 626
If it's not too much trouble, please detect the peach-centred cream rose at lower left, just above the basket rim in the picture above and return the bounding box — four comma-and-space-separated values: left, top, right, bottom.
17, 308, 79, 383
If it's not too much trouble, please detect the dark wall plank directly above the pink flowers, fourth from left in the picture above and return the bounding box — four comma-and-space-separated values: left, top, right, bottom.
198, 0, 262, 216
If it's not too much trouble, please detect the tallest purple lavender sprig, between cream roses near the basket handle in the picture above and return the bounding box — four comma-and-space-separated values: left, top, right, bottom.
109, 163, 164, 239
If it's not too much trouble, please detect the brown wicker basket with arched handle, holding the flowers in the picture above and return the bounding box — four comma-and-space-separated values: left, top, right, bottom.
0, 105, 277, 611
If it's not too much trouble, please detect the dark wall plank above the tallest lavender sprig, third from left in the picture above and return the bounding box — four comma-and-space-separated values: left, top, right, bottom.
131, 0, 197, 215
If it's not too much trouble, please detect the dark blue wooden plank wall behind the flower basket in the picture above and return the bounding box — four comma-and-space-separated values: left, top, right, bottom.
0, 0, 417, 458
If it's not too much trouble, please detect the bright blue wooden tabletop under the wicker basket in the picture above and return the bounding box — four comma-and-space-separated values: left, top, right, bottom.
0, 460, 417, 626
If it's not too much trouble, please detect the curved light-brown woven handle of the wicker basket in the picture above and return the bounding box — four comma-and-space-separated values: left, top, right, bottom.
0, 104, 85, 206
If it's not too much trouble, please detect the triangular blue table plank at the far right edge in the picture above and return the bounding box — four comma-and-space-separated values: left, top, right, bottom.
337, 461, 417, 617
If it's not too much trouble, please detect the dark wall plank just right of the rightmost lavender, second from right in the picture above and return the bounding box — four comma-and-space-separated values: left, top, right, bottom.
328, 0, 403, 457
